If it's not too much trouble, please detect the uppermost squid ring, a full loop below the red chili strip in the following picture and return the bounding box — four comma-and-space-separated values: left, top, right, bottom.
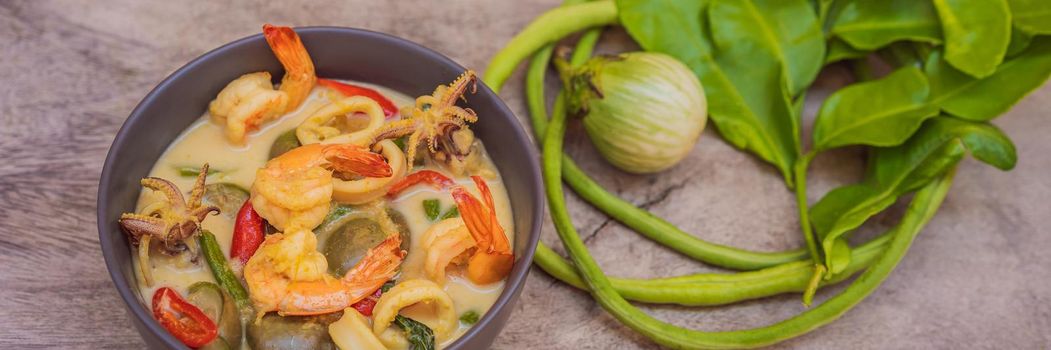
295, 96, 386, 145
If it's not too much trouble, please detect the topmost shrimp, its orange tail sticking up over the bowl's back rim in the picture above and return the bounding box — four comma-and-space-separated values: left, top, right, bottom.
208, 24, 317, 145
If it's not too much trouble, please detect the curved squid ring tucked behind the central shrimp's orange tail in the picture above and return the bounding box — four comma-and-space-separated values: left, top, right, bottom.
332, 138, 408, 204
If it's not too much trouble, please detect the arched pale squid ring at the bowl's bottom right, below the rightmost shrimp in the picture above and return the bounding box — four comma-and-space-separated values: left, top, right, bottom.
372, 279, 459, 342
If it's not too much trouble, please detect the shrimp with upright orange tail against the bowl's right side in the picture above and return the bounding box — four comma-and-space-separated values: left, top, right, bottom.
423, 177, 515, 285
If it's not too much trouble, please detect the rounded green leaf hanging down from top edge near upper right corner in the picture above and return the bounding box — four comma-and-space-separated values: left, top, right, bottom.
934, 0, 1011, 78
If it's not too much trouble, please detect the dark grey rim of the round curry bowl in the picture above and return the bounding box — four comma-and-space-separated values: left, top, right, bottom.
96, 26, 545, 349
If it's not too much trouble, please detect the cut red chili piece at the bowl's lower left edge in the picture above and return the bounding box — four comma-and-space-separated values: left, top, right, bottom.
153, 287, 219, 348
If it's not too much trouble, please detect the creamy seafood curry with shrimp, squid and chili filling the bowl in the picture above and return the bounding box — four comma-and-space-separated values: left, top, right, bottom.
115, 24, 515, 349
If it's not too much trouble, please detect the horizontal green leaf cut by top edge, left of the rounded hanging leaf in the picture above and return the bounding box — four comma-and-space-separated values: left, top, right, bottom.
830, 0, 942, 49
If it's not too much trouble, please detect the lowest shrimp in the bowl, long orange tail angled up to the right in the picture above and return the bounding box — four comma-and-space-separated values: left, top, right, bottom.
244, 227, 406, 317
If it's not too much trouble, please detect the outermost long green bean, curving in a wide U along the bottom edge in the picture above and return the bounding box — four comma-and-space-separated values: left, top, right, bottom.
543, 76, 953, 349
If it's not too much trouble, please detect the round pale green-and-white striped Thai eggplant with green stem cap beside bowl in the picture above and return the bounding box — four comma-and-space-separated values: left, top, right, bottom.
555, 53, 707, 173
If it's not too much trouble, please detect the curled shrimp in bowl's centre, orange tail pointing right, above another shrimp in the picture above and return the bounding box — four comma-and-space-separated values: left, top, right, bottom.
250, 144, 393, 230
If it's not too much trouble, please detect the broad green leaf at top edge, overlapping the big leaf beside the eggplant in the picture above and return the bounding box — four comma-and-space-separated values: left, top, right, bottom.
709, 0, 825, 97
